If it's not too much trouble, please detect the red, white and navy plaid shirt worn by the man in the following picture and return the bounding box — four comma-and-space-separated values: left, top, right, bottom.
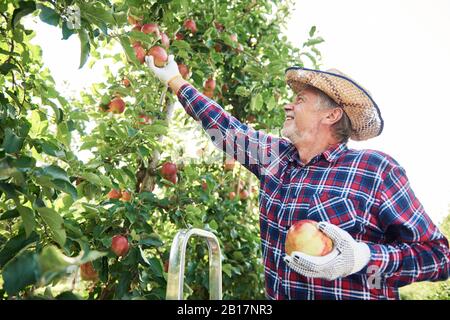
178, 84, 450, 299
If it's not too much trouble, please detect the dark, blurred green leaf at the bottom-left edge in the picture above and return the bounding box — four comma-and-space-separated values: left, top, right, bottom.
2, 252, 40, 295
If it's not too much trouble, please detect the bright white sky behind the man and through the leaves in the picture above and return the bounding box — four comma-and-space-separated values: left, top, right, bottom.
24, 0, 450, 222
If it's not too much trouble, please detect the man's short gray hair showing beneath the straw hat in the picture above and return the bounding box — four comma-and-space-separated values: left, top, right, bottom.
307, 86, 353, 142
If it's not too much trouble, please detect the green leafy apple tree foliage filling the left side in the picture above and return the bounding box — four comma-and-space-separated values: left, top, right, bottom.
0, 0, 323, 299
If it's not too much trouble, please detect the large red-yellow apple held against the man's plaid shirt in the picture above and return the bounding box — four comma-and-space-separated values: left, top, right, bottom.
285, 220, 333, 256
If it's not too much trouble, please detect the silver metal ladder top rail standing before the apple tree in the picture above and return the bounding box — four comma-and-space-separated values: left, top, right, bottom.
166, 228, 222, 300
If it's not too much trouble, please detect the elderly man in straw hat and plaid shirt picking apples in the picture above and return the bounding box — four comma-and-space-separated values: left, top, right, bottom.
146, 56, 450, 299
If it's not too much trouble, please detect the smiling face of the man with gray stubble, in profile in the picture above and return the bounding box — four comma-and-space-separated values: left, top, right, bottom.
281, 88, 323, 144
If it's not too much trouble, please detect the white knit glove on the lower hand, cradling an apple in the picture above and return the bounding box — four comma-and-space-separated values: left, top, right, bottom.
284, 222, 370, 280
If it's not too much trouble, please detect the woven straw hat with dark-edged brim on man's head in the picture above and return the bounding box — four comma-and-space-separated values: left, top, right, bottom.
285, 67, 383, 141
